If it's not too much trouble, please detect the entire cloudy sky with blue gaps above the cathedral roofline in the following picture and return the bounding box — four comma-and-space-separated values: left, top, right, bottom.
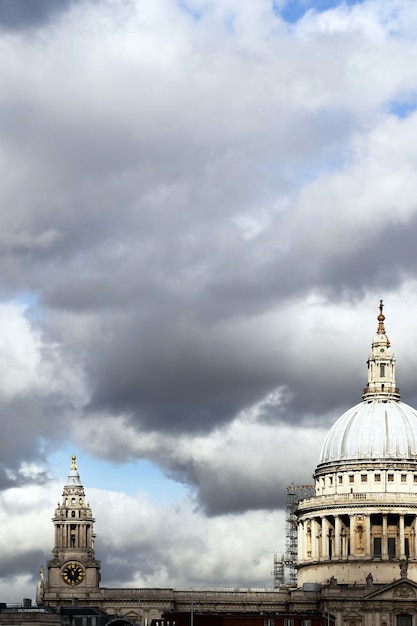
0, 0, 417, 602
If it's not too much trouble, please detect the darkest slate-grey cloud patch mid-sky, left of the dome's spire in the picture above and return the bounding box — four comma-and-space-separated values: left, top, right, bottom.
84, 311, 275, 432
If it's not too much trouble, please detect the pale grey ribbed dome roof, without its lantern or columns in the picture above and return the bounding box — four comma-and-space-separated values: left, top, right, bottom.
319, 400, 417, 464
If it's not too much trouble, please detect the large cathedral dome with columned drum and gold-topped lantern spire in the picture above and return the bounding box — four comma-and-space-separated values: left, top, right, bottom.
296, 301, 417, 588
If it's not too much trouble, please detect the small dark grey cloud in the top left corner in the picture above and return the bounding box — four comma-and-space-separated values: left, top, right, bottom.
0, 0, 79, 30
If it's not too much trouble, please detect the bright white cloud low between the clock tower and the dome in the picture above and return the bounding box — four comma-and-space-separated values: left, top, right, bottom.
92, 490, 284, 587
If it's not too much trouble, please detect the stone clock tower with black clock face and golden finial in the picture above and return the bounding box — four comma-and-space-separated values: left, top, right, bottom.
37, 455, 100, 606
